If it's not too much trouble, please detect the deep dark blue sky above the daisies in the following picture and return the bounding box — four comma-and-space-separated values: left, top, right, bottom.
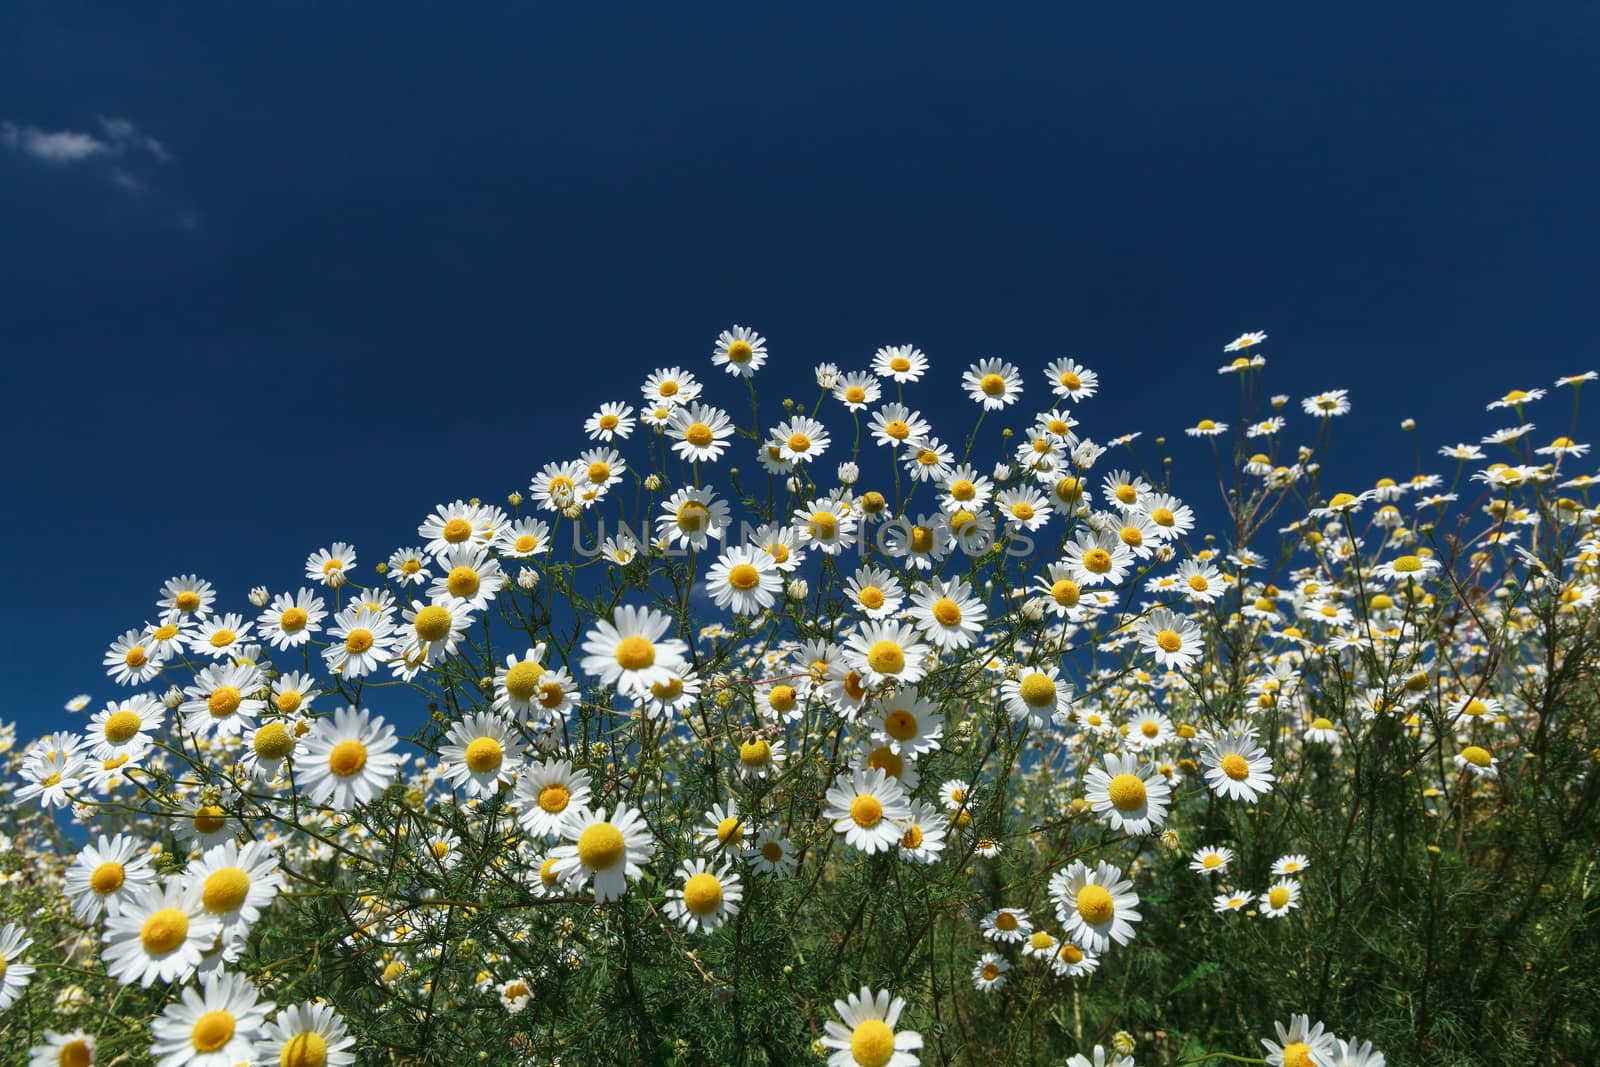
0, 2, 1600, 729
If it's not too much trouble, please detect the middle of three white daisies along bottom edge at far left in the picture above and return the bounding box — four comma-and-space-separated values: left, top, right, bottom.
150, 974, 274, 1067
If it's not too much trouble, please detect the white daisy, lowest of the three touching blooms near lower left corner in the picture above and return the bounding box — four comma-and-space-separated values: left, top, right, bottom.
101, 878, 222, 989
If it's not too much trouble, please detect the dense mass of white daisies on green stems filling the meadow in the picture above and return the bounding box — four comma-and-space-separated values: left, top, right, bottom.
0, 326, 1600, 1067
